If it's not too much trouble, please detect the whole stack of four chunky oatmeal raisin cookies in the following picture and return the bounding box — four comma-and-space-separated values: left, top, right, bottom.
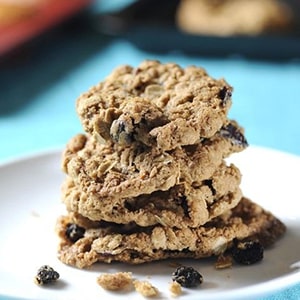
57, 61, 284, 268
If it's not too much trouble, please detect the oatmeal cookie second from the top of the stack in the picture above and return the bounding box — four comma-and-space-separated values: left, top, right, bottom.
62, 121, 247, 202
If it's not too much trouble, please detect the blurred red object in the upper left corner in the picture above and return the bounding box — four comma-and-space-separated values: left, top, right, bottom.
0, 0, 92, 55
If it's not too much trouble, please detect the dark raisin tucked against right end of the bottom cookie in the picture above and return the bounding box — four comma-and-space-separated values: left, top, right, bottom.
232, 241, 264, 265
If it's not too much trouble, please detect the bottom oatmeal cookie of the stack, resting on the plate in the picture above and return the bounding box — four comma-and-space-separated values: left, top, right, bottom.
57, 198, 285, 268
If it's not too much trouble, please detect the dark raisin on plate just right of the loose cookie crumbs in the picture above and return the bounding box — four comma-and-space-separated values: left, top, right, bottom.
172, 266, 203, 287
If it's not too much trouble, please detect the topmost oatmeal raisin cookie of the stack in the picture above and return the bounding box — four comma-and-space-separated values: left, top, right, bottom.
76, 61, 232, 150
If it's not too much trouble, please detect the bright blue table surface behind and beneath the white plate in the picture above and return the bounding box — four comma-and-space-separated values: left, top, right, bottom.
0, 1, 300, 300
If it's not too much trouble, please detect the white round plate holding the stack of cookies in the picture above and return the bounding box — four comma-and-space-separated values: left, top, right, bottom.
0, 147, 300, 300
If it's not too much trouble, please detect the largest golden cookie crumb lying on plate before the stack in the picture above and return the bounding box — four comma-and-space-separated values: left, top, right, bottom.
97, 272, 132, 291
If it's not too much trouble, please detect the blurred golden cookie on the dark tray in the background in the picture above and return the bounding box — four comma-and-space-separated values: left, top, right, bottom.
176, 0, 293, 36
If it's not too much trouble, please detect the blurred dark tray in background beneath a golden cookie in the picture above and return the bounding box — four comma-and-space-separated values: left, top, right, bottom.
96, 0, 300, 59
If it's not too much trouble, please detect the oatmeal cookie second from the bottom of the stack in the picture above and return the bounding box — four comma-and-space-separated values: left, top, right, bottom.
62, 164, 242, 228
